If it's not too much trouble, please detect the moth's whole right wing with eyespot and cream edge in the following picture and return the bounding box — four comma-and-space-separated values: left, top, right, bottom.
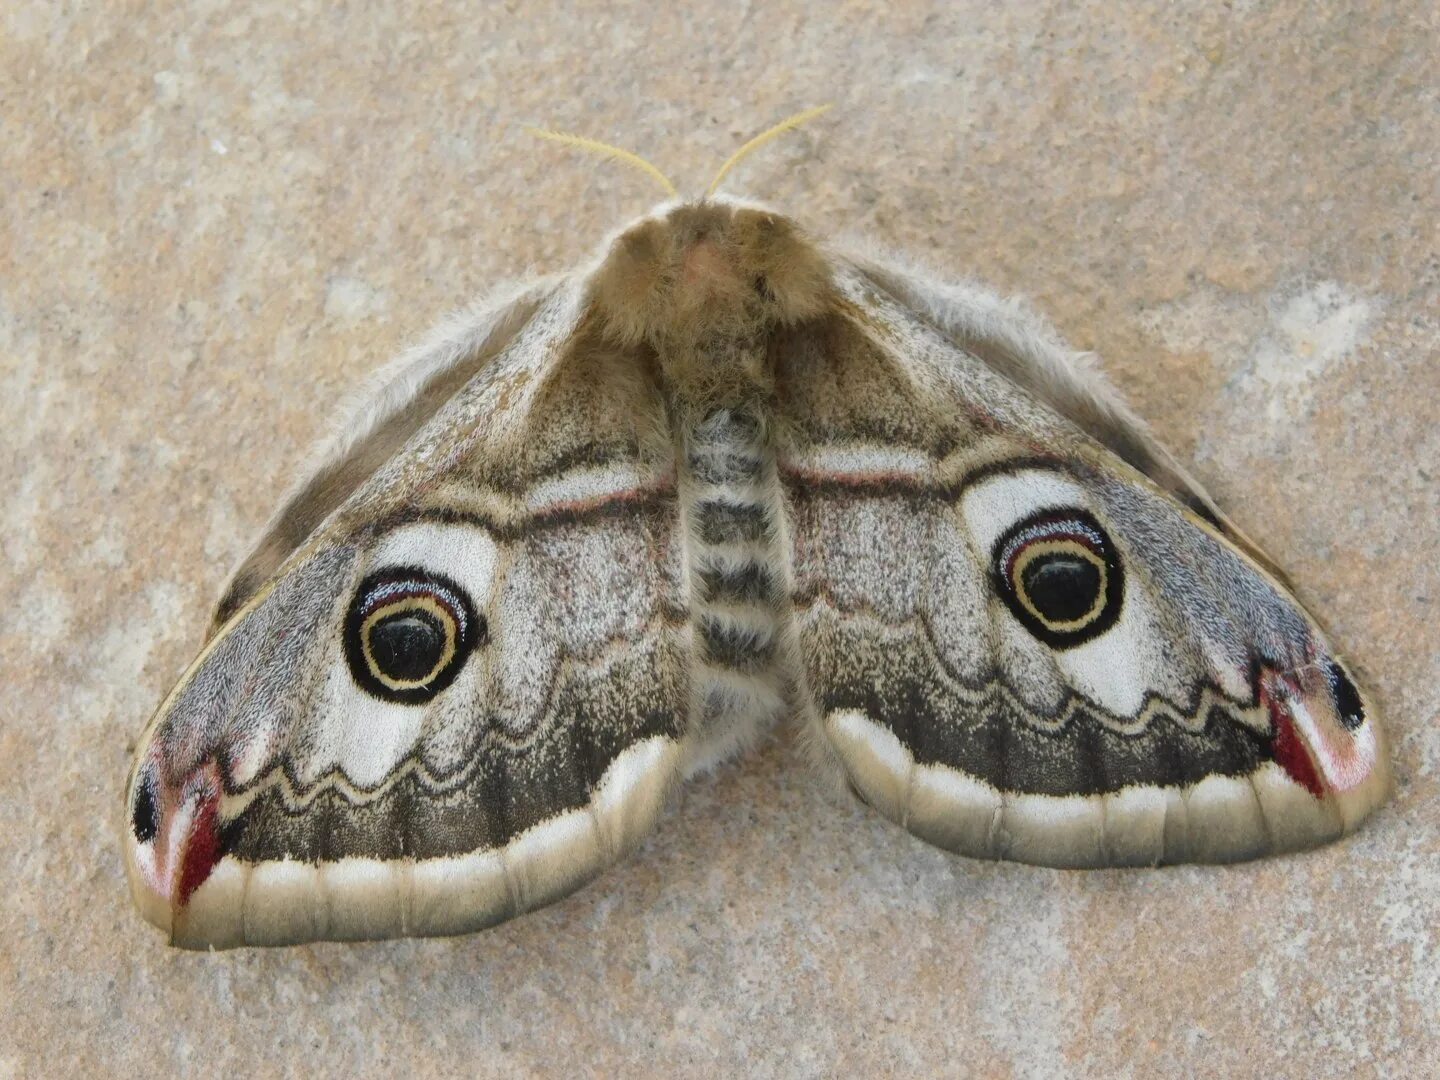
775, 262, 1388, 867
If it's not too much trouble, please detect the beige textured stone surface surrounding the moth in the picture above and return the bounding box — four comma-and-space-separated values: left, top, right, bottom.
0, 0, 1440, 1077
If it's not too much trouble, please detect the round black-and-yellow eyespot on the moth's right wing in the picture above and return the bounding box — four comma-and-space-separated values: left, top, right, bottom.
991, 507, 1125, 648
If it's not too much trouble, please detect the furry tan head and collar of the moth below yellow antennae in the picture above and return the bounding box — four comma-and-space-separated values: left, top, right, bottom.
592, 204, 831, 347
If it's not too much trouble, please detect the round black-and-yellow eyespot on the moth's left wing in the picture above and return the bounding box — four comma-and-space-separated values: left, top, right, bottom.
344, 567, 487, 704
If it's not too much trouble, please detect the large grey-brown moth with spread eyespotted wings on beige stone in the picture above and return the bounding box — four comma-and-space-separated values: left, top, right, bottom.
124, 114, 1388, 948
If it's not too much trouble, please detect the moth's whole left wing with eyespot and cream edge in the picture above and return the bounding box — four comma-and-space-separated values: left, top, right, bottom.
125, 281, 688, 948
